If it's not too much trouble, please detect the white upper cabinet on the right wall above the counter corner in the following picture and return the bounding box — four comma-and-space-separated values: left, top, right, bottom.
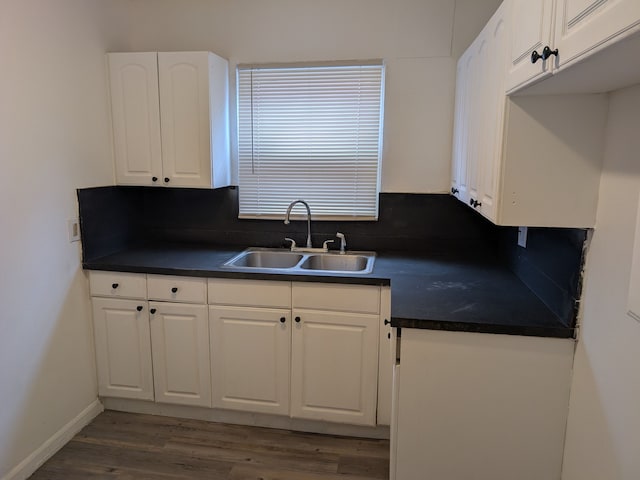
452, 2, 607, 227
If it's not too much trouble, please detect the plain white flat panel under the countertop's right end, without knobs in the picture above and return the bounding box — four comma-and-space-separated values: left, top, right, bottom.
391, 329, 574, 480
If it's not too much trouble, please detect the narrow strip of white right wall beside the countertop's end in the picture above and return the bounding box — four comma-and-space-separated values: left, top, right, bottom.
562, 86, 640, 480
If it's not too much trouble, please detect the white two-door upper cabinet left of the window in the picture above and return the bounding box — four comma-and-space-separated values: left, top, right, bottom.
108, 52, 229, 188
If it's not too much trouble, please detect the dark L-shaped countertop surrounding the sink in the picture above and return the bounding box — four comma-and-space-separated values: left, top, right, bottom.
83, 245, 574, 338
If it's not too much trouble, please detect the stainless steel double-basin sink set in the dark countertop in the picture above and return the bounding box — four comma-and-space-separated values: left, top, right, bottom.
222, 248, 376, 275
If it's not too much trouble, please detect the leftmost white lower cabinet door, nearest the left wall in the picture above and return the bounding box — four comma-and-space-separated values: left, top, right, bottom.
92, 297, 153, 400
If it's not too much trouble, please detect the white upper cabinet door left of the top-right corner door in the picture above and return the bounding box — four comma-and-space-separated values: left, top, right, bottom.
505, 0, 555, 91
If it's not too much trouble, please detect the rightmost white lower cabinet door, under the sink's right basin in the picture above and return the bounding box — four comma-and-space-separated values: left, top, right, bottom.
291, 309, 379, 425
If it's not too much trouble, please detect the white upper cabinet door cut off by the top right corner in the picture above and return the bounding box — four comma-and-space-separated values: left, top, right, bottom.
555, 0, 640, 66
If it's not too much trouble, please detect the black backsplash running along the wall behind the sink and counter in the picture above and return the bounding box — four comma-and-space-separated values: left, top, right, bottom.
78, 186, 587, 327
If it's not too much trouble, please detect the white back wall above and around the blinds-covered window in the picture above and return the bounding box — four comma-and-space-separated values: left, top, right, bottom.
117, 0, 501, 193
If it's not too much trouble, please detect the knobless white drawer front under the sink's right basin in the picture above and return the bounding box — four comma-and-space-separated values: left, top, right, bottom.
291, 282, 380, 314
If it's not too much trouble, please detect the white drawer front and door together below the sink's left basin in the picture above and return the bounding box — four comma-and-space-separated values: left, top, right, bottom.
209, 279, 291, 415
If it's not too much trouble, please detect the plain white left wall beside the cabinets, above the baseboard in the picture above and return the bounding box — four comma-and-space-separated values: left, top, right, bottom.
0, 0, 127, 478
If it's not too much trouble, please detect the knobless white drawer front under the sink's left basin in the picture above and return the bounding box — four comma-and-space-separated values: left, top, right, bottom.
209, 278, 291, 308
